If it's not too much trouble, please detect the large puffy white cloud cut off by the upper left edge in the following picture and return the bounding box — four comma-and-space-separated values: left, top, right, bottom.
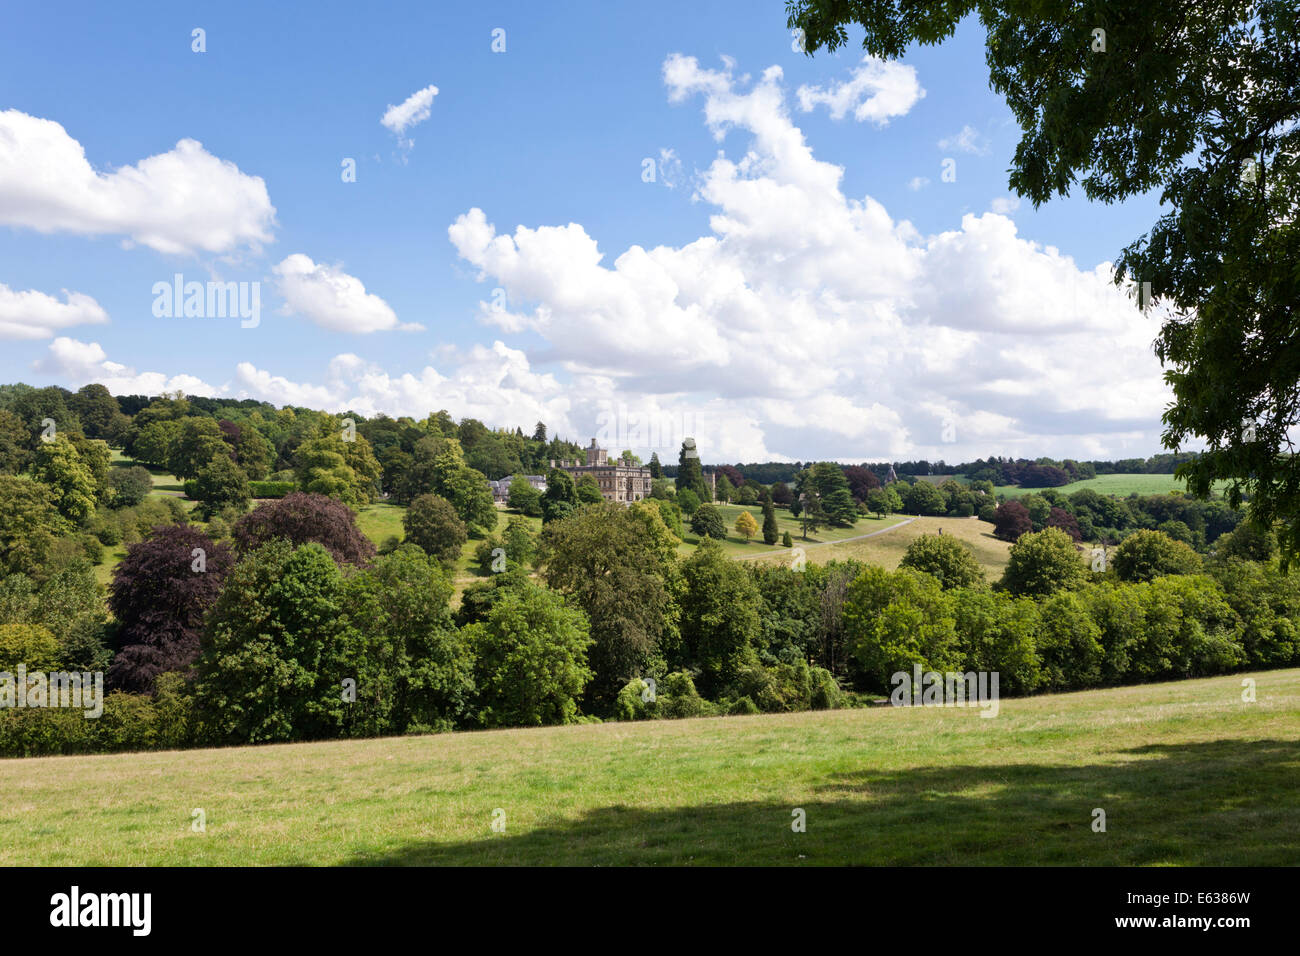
0, 109, 276, 255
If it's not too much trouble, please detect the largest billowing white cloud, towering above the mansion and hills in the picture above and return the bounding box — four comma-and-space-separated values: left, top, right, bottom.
447, 55, 1167, 460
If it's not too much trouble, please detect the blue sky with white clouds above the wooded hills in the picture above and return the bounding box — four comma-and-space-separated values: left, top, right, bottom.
0, 0, 1171, 463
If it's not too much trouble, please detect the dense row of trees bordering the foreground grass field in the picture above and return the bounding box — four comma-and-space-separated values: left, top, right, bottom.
0, 470, 1300, 753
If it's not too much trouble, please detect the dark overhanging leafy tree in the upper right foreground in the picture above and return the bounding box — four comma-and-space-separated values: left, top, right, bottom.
787, 0, 1300, 558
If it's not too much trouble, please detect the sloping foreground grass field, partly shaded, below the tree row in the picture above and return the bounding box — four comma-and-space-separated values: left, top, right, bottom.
0, 670, 1300, 865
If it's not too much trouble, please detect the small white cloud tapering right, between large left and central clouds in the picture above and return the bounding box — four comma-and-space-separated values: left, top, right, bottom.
272, 252, 424, 334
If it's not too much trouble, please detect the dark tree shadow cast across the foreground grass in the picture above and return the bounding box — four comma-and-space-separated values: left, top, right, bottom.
347, 740, 1300, 866
